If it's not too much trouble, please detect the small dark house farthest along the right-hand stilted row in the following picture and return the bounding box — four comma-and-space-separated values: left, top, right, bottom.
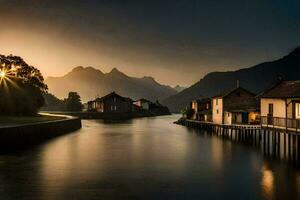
192, 98, 212, 121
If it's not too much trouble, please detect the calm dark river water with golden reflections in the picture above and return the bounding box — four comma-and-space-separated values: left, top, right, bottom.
0, 115, 300, 200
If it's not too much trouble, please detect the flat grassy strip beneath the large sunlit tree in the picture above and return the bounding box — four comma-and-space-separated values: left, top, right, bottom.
0, 115, 64, 126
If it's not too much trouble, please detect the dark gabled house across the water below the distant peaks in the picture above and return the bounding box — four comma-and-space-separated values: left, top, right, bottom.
88, 92, 133, 113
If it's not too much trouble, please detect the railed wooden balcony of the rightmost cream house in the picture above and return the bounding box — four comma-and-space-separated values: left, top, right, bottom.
261, 116, 300, 132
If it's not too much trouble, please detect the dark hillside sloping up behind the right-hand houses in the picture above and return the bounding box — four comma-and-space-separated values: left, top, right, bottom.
162, 47, 300, 112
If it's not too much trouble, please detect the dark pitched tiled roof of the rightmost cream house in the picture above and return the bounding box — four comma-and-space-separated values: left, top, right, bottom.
259, 81, 300, 98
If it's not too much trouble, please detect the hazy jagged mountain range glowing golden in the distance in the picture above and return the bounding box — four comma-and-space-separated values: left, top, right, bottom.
45, 67, 177, 102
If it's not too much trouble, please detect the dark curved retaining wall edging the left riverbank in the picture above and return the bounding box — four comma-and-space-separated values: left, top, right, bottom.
0, 116, 81, 154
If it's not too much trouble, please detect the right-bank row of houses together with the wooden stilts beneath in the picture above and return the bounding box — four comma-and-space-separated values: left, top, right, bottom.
175, 81, 300, 160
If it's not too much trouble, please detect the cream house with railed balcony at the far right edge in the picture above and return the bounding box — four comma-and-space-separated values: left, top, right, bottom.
260, 81, 300, 130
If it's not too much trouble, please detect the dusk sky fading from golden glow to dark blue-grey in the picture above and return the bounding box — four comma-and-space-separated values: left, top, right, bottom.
0, 0, 300, 86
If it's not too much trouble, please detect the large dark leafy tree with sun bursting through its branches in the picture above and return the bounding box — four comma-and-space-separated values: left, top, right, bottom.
0, 55, 48, 115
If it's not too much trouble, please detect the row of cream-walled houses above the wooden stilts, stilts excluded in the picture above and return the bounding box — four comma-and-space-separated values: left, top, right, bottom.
180, 81, 300, 132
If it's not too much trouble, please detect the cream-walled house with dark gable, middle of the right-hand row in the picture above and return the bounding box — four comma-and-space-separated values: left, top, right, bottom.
212, 87, 260, 124
